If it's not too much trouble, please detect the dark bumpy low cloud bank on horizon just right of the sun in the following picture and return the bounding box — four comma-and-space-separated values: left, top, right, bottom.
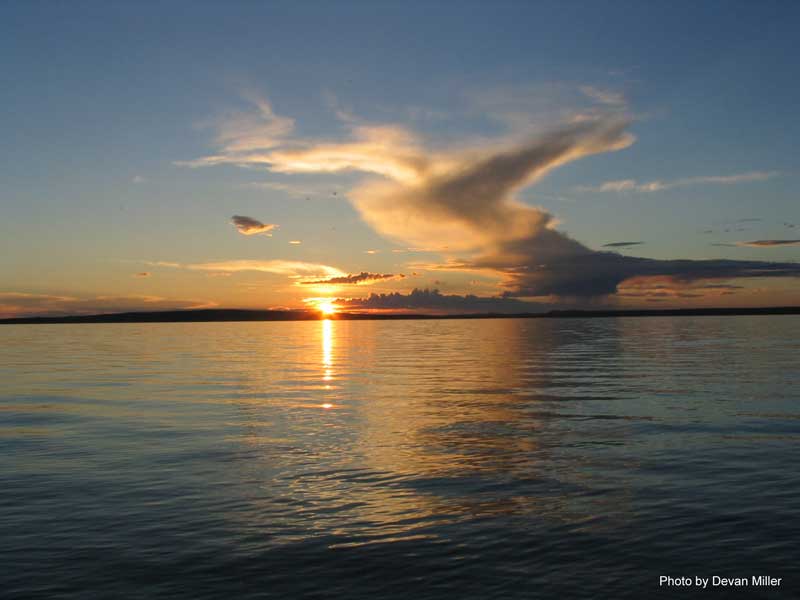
336, 288, 550, 313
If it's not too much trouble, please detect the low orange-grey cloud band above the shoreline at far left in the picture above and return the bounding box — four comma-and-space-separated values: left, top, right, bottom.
0, 292, 216, 318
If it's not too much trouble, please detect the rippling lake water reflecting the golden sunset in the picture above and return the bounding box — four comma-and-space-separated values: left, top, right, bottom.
0, 316, 800, 600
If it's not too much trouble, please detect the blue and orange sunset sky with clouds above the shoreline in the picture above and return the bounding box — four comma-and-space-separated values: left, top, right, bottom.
0, 0, 800, 316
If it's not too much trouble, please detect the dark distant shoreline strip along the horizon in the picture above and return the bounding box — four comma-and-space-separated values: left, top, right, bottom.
0, 306, 800, 325
